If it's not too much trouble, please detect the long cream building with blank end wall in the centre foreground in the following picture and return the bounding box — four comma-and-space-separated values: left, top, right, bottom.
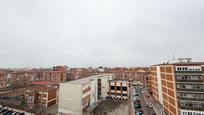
58, 74, 112, 115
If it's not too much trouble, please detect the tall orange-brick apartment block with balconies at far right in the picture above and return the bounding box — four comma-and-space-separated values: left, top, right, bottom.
150, 59, 204, 115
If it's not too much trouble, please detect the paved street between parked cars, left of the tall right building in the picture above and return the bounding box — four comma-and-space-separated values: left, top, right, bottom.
136, 88, 155, 115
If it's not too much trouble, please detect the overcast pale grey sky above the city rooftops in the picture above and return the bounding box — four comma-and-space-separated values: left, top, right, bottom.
0, 0, 204, 67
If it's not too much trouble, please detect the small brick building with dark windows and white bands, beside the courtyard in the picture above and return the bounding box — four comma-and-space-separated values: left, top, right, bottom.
109, 80, 130, 100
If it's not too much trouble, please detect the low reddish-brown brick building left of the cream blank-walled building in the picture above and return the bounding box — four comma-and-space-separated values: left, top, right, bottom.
25, 86, 57, 109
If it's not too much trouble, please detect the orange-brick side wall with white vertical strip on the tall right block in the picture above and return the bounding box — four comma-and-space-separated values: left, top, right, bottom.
150, 65, 178, 115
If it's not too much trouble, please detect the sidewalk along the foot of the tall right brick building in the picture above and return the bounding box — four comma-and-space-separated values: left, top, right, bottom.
143, 89, 164, 115
